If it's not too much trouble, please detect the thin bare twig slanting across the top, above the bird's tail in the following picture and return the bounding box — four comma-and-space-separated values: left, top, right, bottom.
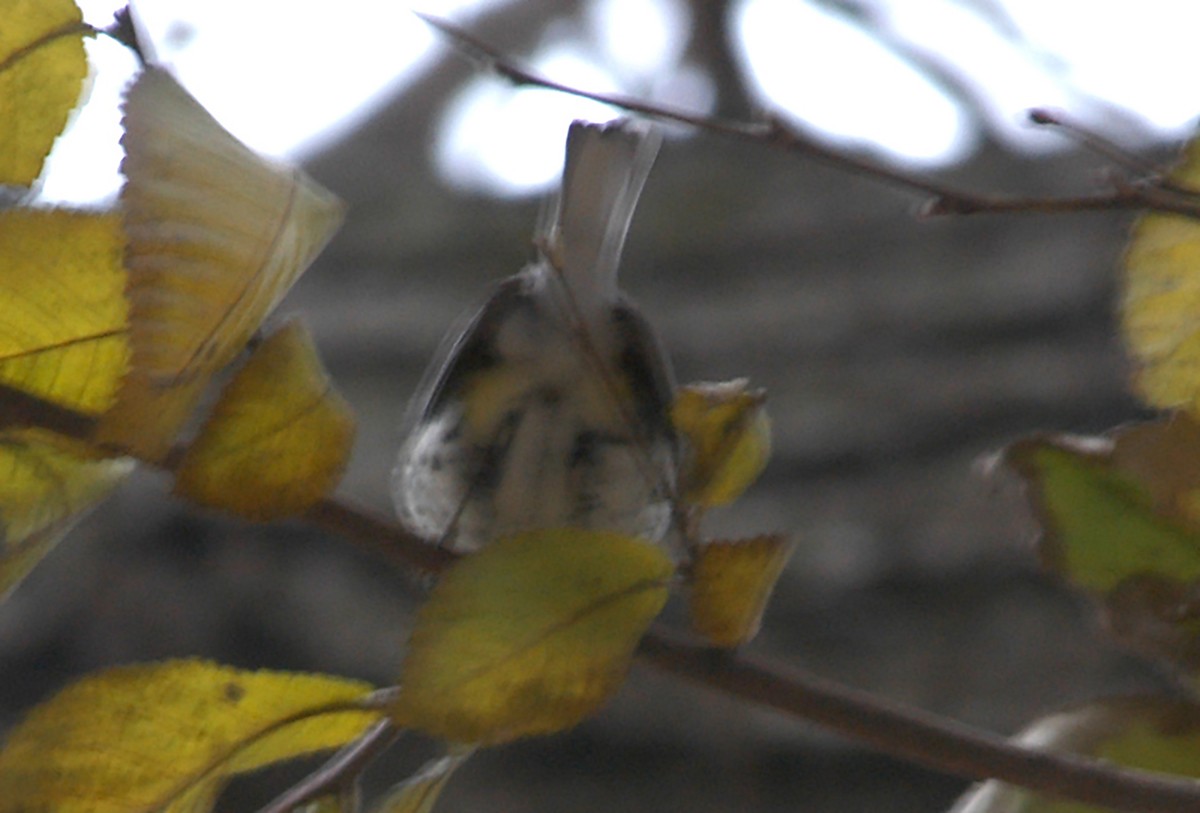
418, 14, 1200, 219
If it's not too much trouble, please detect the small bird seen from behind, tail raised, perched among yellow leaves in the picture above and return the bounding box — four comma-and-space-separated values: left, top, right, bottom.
392, 120, 678, 553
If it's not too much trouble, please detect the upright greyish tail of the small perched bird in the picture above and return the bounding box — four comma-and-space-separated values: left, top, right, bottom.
548, 119, 662, 314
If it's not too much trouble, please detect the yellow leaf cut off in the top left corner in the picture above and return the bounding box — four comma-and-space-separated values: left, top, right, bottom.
0, 0, 88, 186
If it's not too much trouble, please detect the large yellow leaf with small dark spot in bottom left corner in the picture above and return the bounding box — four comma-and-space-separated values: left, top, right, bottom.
0, 661, 379, 813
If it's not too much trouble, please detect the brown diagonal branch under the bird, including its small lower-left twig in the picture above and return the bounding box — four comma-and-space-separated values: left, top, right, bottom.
7, 393, 1200, 813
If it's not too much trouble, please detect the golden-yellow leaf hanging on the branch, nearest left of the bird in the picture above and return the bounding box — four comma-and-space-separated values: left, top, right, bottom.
175, 321, 354, 520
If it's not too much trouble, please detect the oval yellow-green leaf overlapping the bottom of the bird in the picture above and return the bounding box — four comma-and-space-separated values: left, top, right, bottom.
392, 529, 672, 745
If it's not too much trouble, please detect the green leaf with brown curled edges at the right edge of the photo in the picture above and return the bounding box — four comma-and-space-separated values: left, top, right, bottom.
1006, 426, 1200, 674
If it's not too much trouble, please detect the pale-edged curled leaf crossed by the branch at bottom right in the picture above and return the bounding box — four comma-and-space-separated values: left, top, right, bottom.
952, 695, 1200, 813
